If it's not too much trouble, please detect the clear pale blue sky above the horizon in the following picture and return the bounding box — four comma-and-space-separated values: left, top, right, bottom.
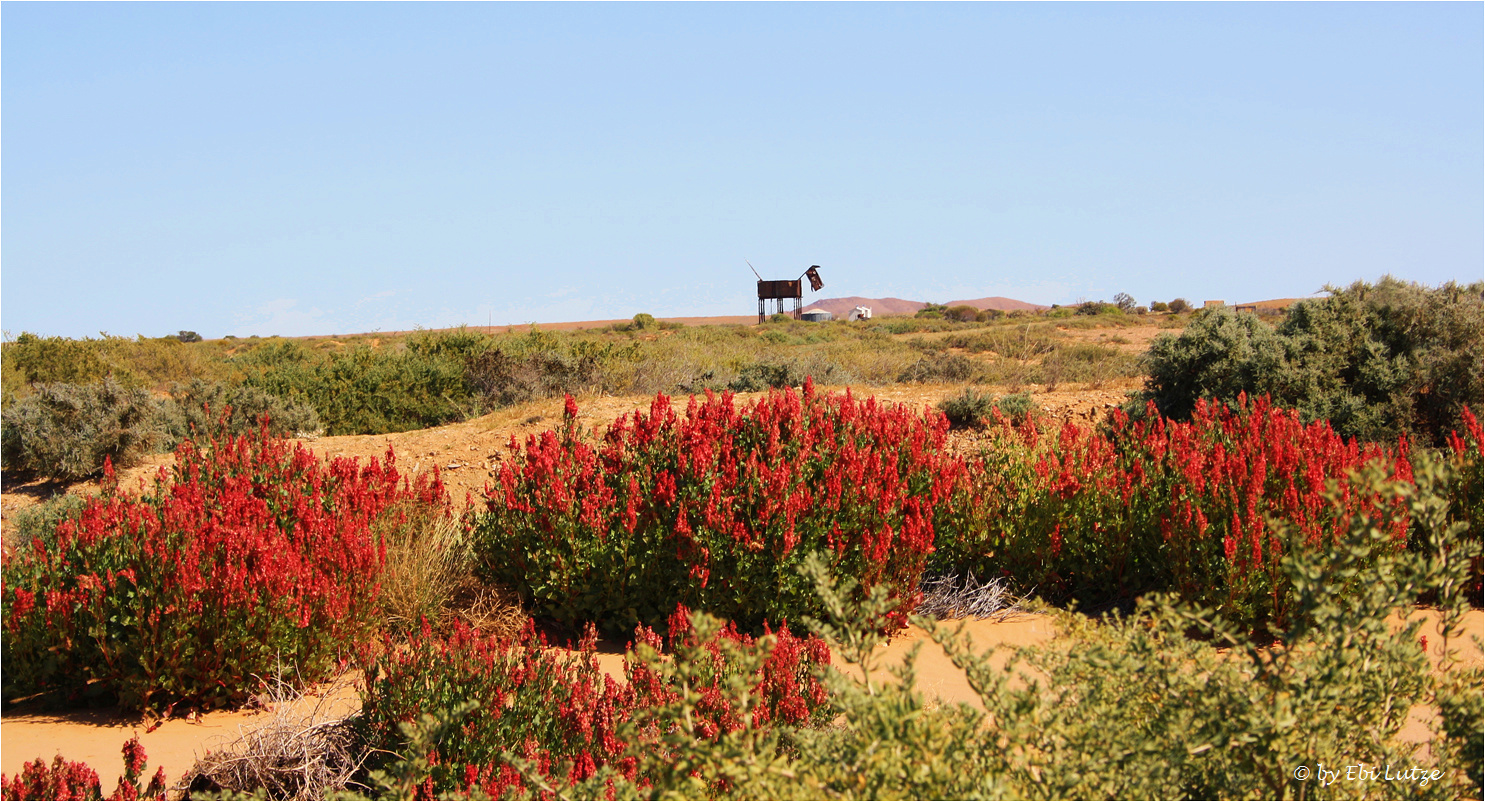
0, 1, 1485, 337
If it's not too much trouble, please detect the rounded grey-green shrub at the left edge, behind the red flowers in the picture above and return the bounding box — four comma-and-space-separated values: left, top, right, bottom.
0, 379, 169, 480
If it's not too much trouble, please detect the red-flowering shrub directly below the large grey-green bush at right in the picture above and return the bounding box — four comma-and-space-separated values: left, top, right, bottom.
940, 397, 1449, 625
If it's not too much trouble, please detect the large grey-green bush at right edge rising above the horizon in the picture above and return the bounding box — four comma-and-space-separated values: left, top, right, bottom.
1132, 278, 1485, 446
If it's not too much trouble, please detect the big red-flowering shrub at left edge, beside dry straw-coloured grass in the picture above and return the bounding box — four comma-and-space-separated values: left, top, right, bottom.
0, 421, 443, 710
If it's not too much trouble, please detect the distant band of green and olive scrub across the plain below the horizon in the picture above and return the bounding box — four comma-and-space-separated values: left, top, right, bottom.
0, 310, 1139, 478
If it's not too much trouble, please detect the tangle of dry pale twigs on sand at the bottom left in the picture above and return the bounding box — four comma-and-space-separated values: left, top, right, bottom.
175, 676, 370, 799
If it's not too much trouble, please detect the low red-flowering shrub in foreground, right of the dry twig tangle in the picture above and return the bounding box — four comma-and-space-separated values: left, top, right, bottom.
358, 609, 830, 799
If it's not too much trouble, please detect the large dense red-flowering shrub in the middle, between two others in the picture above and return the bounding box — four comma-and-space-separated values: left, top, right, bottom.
475, 382, 965, 631
